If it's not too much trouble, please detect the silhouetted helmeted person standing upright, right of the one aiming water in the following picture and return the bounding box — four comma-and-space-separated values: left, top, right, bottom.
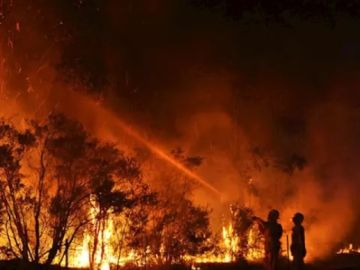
290, 213, 306, 270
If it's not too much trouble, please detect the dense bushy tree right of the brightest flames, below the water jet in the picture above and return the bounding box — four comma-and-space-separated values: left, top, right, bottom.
150, 148, 213, 263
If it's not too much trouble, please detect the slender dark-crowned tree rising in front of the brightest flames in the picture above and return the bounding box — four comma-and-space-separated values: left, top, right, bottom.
89, 145, 141, 269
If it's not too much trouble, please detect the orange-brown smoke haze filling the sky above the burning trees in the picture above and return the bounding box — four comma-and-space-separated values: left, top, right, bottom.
0, 0, 360, 258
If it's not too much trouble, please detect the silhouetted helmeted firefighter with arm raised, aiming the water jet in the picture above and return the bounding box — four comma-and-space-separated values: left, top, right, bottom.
254, 209, 283, 270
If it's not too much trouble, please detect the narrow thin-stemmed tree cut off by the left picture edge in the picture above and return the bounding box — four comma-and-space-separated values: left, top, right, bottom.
0, 121, 35, 261
